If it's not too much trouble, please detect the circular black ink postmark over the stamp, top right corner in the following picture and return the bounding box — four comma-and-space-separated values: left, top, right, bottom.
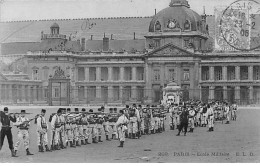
220, 0, 260, 51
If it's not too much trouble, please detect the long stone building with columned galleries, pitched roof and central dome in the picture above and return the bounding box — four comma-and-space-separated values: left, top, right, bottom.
0, 0, 260, 105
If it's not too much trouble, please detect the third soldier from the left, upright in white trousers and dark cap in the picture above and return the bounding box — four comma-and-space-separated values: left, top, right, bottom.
36, 109, 50, 152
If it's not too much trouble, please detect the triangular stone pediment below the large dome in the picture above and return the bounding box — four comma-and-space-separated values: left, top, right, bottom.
147, 43, 194, 57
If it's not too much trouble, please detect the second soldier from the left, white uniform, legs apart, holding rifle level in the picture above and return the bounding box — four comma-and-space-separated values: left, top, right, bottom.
14, 110, 33, 156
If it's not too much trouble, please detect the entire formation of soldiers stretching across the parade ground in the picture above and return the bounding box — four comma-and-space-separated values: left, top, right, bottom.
0, 101, 237, 157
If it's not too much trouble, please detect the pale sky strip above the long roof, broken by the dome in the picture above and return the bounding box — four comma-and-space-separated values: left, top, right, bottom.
0, 0, 238, 21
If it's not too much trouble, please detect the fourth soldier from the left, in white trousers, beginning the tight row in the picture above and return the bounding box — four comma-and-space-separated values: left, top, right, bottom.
51, 109, 62, 150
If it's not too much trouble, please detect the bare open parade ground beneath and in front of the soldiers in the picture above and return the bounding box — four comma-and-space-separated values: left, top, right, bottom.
0, 107, 260, 163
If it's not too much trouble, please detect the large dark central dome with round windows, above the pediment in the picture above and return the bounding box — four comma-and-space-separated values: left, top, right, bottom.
149, 0, 202, 32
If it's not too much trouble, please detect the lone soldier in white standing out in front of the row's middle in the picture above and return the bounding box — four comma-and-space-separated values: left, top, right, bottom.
116, 110, 129, 147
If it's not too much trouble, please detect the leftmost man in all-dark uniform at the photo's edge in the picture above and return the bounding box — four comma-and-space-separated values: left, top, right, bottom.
0, 107, 17, 157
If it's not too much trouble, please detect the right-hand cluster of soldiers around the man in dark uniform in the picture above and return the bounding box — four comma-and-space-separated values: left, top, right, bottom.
168, 101, 237, 136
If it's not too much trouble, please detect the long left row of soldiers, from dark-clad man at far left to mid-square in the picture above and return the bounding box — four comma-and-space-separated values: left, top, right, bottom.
0, 104, 166, 157
